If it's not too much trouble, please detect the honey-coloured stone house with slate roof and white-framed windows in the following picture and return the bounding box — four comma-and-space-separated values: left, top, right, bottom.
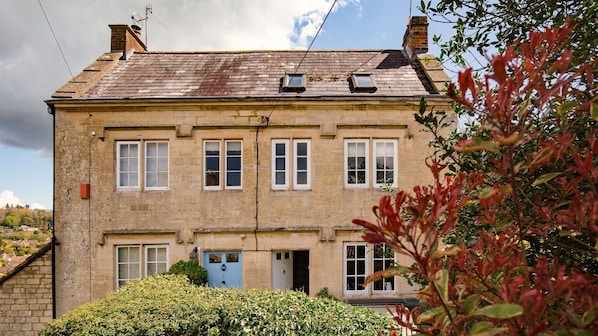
47, 17, 452, 316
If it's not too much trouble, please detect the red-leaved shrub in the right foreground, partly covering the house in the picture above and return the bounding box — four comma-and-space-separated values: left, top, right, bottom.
353, 22, 598, 335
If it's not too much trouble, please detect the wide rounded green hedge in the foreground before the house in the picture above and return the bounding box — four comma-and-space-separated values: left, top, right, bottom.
40, 274, 392, 336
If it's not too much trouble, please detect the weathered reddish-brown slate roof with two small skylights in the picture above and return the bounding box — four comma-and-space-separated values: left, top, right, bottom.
79, 50, 446, 99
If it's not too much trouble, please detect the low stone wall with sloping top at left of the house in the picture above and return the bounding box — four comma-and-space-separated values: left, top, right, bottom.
0, 244, 52, 335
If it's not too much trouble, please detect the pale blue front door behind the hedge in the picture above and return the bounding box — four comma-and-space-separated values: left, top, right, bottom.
204, 251, 243, 288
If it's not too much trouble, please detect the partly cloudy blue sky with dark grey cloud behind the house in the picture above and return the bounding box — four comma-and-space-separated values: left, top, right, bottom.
0, 0, 450, 209
